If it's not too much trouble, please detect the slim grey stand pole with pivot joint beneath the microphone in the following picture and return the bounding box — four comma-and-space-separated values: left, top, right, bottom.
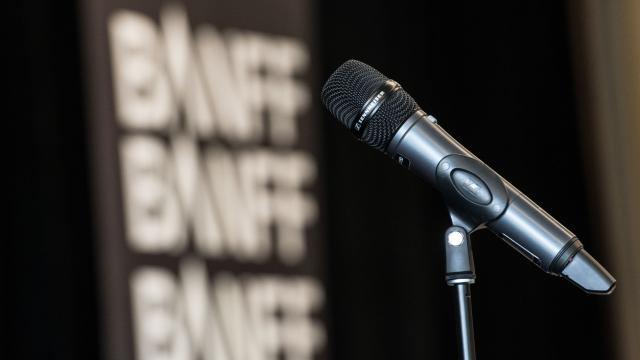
444, 226, 476, 360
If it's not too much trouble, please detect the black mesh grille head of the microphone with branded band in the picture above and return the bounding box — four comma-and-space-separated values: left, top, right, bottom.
322, 60, 420, 152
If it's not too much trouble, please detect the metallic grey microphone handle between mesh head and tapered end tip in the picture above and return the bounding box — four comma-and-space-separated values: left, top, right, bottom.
387, 110, 582, 275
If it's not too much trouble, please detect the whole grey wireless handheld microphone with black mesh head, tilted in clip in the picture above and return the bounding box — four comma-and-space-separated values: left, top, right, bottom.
322, 60, 616, 294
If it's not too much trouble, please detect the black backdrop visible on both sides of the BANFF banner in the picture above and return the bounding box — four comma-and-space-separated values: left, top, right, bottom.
7, 0, 609, 359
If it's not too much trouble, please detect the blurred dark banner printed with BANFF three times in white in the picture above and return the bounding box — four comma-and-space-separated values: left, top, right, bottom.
83, 0, 327, 360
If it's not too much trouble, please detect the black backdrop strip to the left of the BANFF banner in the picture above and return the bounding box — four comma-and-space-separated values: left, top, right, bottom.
8, 1, 99, 360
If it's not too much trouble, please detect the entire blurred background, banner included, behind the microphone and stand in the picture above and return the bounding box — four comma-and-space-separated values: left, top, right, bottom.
2, 0, 640, 360
